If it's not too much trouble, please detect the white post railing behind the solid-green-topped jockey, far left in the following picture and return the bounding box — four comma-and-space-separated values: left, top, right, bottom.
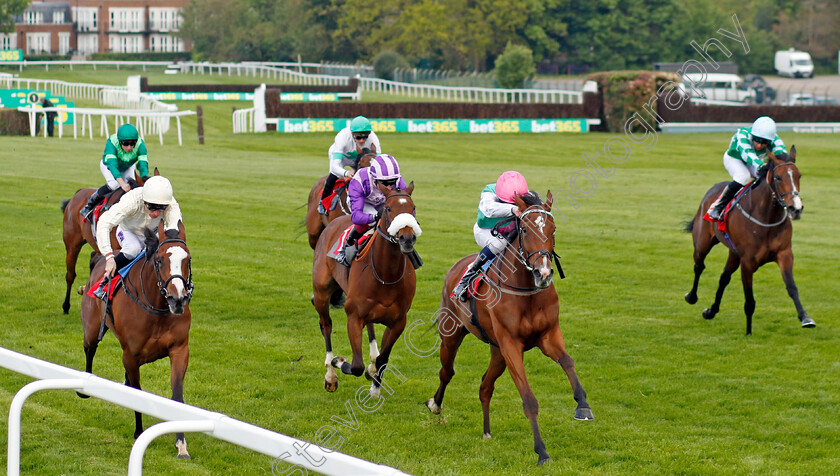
18, 106, 196, 145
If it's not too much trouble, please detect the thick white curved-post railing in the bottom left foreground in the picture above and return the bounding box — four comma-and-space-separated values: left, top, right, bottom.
0, 347, 405, 476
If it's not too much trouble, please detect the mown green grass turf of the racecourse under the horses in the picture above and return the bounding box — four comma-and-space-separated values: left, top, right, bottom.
0, 92, 840, 475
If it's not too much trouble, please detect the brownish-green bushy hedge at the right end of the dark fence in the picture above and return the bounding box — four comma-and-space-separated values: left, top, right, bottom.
587, 71, 680, 132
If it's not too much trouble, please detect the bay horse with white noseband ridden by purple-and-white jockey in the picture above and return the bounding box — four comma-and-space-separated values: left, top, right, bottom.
312, 182, 421, 397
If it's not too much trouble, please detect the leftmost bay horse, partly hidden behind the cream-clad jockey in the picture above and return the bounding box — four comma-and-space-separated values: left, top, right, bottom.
61, 172, 153, 314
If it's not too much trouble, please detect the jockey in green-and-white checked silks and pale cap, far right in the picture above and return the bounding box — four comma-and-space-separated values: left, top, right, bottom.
709, 116, 787, 220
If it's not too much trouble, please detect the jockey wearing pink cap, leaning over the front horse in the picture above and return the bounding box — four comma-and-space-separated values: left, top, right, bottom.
450, 170, 529, 301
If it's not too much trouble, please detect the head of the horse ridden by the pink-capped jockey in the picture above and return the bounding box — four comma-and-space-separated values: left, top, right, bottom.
515, 191, 555, 289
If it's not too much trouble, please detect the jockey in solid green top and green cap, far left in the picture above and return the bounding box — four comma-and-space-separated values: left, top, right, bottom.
79, 124, 149, 221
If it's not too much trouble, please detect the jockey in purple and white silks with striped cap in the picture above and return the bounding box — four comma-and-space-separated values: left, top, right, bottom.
336, 154, 407, 265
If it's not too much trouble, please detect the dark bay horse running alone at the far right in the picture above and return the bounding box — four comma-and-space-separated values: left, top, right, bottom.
685, 147, 816, 335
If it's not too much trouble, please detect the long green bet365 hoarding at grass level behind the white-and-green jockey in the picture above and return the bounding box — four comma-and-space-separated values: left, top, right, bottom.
277, 118, 589, 134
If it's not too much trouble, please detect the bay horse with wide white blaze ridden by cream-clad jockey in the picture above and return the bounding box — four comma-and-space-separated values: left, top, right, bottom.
80, 223, 193, 458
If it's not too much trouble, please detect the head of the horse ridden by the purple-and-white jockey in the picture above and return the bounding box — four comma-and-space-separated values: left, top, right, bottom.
378, 181, 423, 254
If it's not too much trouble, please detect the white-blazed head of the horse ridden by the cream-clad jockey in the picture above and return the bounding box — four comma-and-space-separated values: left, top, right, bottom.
146, 222, 193, 315
